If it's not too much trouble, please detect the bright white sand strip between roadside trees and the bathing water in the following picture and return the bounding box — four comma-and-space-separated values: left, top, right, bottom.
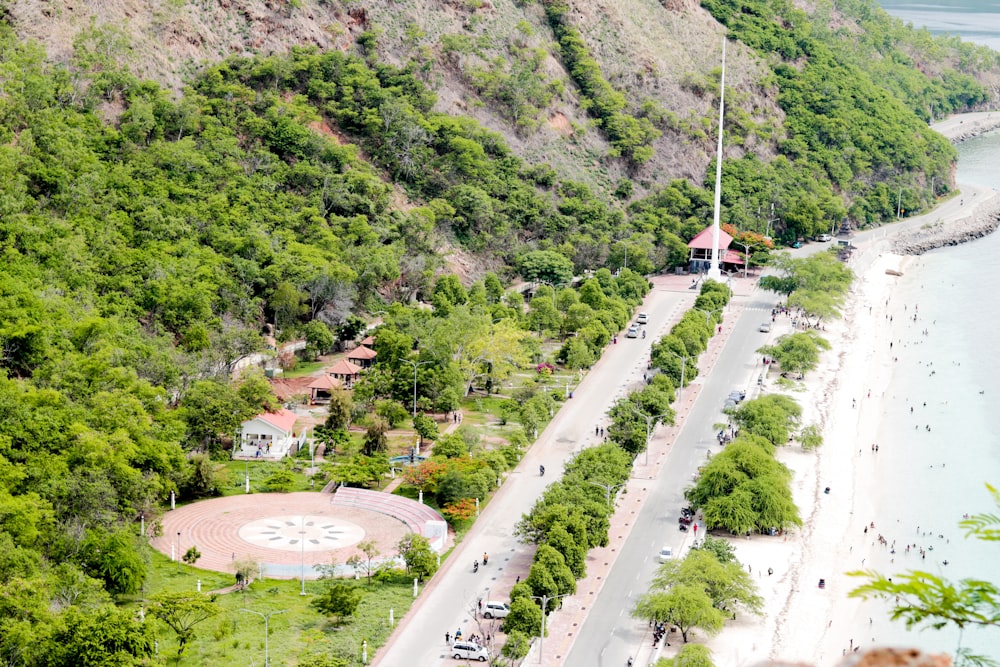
707, 255, 906, 665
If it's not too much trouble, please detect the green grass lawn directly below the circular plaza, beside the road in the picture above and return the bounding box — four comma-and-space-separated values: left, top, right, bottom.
146, 553, 413, 667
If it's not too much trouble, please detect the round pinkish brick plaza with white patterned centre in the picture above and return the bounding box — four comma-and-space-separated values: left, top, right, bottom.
151, 492, 432, 579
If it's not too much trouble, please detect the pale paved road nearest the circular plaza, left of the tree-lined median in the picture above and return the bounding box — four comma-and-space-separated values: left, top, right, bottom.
375, 280, 696, 667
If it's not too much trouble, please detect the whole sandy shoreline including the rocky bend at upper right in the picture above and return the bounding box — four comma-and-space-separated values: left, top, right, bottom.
697, 114, 1000, 667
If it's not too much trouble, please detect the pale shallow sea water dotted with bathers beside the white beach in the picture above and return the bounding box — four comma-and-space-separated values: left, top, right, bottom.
857, 133, 1000, 659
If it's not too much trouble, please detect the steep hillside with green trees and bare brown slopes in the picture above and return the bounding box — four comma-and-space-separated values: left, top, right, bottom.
0, 0, 1000, 666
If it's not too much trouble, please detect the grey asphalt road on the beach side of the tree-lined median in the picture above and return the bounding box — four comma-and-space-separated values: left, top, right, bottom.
563, 291, 777, 667
